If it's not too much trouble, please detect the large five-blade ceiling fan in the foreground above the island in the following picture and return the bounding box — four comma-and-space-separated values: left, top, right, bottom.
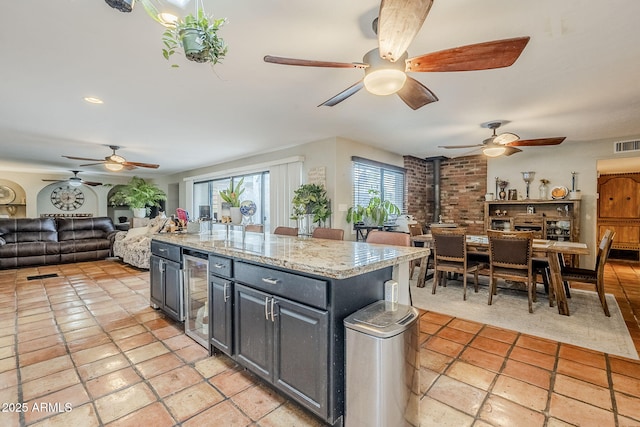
264, 0, 529, 110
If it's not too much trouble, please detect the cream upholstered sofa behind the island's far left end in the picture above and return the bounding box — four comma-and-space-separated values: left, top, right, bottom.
113, 217, 167, 270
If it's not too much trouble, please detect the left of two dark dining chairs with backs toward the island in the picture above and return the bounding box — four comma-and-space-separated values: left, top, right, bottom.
431, 228, 484, 300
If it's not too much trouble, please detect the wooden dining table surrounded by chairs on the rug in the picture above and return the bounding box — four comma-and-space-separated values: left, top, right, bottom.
411, 233, 590, 316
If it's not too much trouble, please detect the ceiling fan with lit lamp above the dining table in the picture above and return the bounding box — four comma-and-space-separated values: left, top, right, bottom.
440, 121, 566, 157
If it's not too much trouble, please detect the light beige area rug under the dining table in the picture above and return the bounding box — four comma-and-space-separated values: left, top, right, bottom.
411, 279, 638, 359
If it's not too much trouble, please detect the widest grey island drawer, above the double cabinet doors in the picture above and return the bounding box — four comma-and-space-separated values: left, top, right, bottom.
235, 262, 328, 309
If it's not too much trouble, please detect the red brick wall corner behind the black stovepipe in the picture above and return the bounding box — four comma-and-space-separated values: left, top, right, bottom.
404, 155, 487, 234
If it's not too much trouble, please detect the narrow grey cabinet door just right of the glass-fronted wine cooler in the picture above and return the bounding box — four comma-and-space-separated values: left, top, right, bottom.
209, 276, 233, 355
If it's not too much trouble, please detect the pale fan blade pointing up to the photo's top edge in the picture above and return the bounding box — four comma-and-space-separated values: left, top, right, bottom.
378, 0, 433, 62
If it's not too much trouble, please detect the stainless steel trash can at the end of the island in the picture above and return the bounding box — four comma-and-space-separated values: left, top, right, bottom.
344, 301, 420, 427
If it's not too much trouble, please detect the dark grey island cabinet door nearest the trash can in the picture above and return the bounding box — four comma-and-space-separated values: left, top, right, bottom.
273, 298, 329, 418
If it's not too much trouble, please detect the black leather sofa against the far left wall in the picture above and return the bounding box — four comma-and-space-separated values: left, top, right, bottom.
0, 217, 117, 269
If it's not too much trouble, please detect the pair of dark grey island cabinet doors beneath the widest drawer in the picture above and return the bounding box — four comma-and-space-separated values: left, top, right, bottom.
234, 284, 329, 418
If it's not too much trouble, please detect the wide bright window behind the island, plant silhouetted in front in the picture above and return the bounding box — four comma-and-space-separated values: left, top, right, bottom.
193, 172, 269, 230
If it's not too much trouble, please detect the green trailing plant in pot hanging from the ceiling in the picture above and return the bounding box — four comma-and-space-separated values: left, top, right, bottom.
162, 0, 228, 67
